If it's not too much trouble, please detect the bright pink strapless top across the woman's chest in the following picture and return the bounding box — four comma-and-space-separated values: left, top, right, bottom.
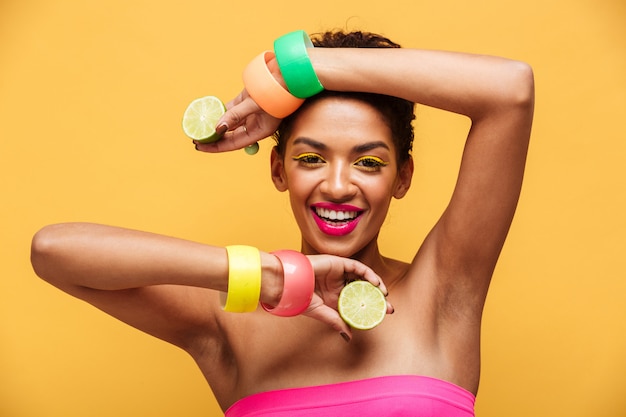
225, 375, 476, 417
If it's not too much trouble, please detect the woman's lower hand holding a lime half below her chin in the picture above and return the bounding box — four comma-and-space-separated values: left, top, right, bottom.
302, 255, 393, 341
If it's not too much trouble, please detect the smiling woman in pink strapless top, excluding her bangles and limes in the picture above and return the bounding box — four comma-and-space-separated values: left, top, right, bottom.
32, 32, 534, 417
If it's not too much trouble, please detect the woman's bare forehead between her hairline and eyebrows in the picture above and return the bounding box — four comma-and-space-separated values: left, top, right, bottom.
286, 97, 395, 151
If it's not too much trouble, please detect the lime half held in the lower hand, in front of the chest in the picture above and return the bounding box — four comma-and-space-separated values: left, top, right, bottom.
338, 281, 387, 330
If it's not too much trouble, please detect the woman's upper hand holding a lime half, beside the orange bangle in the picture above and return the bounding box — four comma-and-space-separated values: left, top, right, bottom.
194, 89, 281, 153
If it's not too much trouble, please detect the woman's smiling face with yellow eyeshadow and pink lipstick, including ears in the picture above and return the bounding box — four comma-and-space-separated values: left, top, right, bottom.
272, 97, 412, 257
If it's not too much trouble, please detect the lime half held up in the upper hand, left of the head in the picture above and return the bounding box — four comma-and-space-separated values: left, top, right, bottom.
183, 96, 226, 143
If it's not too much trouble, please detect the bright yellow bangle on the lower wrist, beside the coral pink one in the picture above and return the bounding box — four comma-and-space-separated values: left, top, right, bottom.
222, 245, 261, 313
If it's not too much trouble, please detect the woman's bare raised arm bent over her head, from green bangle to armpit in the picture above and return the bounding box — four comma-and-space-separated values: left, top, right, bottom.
311, 48, 534, 300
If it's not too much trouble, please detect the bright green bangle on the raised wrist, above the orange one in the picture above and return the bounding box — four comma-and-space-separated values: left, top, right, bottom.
274, 30, 324, 98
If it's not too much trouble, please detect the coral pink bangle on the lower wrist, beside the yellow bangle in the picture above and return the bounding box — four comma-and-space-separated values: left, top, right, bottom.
261, 250, 315, 317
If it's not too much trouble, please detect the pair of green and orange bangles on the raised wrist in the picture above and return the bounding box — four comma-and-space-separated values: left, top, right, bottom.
243, 30, 324, 119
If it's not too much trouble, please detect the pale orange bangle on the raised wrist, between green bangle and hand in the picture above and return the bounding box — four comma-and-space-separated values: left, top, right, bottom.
243, 51, 304, 119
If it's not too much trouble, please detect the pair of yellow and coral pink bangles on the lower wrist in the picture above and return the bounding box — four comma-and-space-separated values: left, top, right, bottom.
223, 245, 315, 317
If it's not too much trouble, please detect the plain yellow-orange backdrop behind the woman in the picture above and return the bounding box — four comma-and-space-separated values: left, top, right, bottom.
0, 0, 626, 417
